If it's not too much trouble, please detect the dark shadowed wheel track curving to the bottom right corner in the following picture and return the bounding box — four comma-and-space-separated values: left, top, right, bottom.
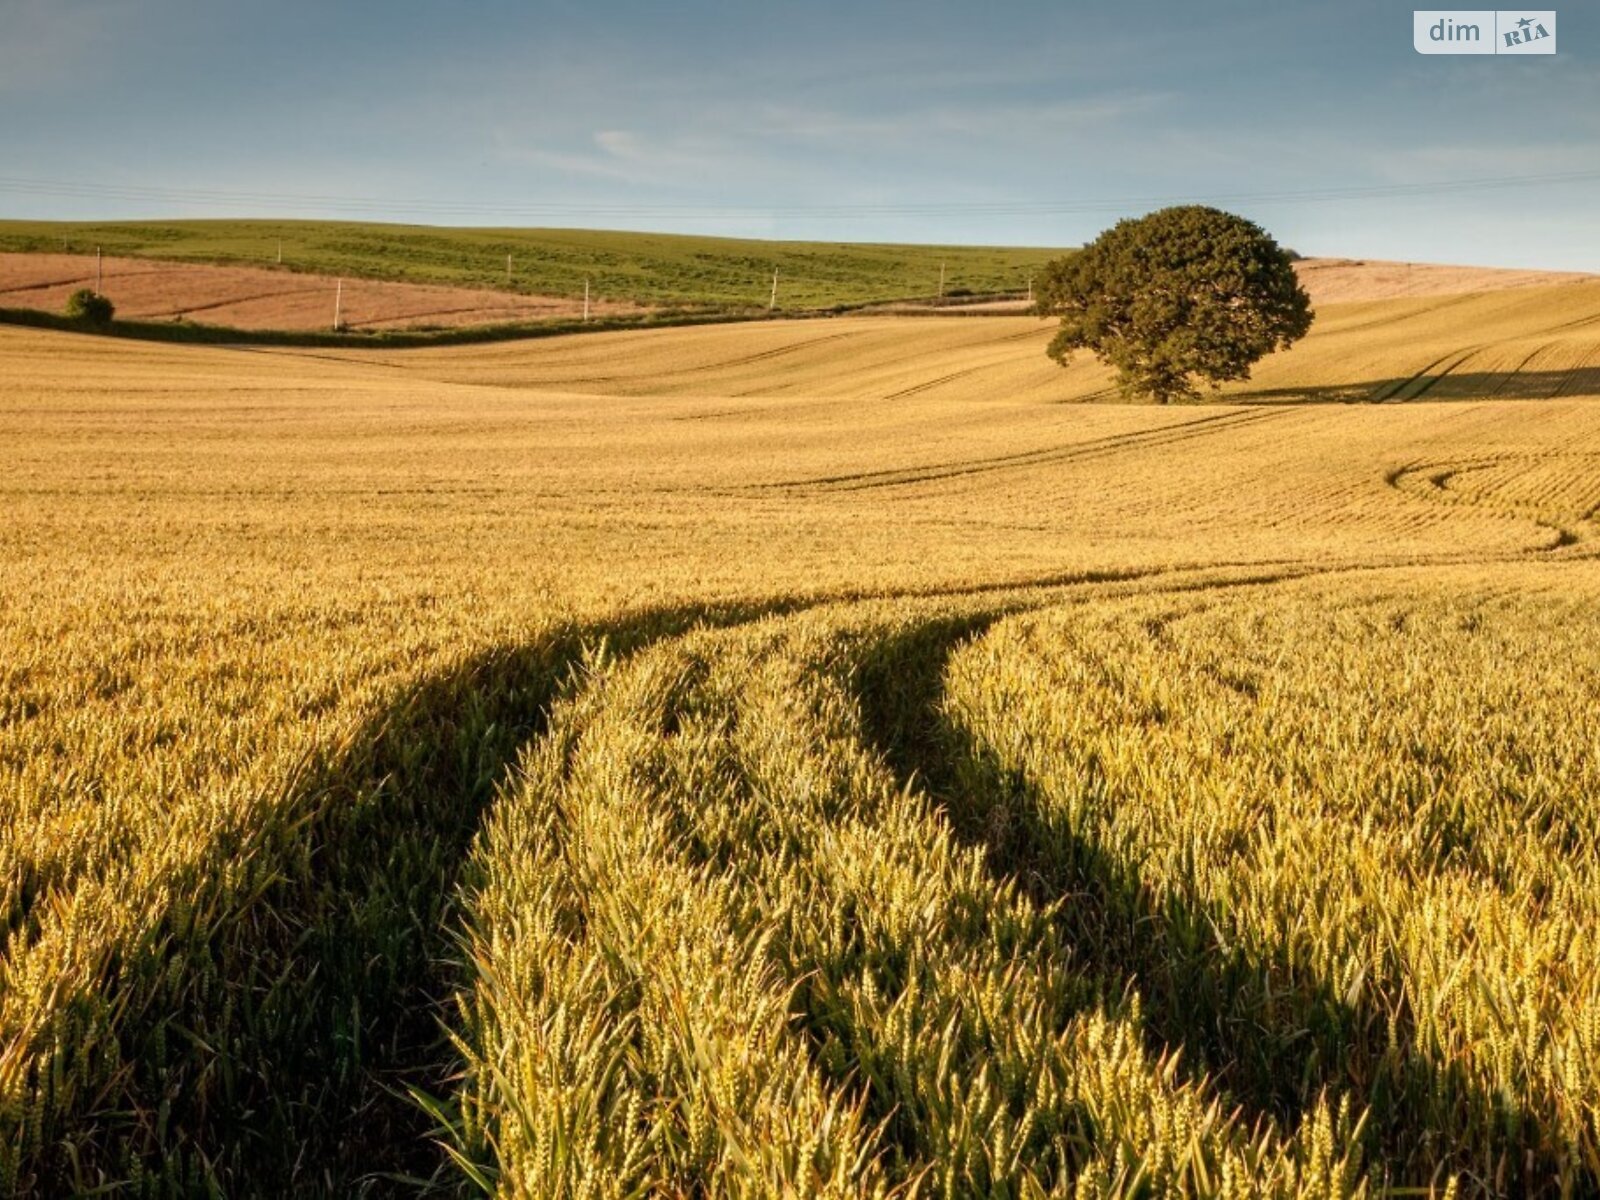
853, 613, 1580, 1195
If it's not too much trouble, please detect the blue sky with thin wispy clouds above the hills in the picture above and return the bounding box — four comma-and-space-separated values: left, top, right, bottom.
0, 0, 1600, 270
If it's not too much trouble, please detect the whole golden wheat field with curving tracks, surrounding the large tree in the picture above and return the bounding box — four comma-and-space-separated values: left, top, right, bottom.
0, 283, 1600, 1198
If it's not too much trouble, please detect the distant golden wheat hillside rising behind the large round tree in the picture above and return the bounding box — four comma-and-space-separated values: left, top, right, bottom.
324, 280, 1600, 406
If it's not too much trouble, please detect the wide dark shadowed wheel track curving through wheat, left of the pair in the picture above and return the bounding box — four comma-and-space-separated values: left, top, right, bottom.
22, 602, 795, 1197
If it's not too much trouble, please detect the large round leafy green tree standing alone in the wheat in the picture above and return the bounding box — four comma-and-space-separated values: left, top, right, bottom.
1037, 205, 1312, 405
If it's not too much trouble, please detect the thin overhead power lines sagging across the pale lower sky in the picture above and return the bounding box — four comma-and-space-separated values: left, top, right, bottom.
0, 171, 1600, 219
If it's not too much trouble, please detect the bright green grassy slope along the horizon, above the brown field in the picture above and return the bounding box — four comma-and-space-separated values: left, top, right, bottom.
0, 221, 1061, 309
